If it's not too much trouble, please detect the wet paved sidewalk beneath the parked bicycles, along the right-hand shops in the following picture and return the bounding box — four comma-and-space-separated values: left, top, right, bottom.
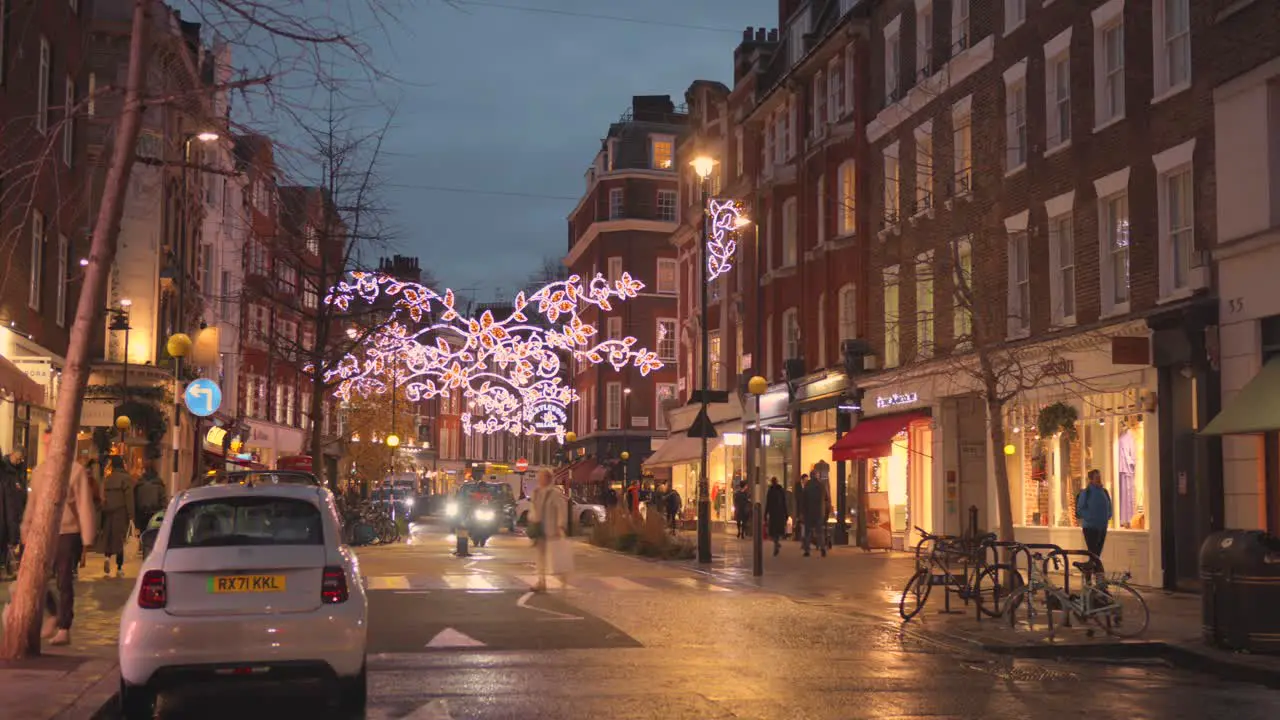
690, 534, 1280, 687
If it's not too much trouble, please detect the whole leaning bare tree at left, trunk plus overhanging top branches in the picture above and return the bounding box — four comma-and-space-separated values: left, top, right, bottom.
0, 0, 396, 659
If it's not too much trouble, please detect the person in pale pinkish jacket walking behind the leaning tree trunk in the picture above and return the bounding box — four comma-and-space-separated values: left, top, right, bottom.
22, 430, 97, 644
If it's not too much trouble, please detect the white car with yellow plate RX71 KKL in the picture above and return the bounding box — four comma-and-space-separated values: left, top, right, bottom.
119, 473, 369, 719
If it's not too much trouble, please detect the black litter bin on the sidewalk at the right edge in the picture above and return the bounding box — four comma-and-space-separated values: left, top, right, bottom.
1201, 530, 1280, 652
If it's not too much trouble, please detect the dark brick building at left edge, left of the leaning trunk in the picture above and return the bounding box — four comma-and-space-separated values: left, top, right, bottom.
0, 0, 92, 460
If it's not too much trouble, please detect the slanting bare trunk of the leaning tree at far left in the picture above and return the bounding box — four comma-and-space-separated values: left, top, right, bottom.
0, 0, 154, 660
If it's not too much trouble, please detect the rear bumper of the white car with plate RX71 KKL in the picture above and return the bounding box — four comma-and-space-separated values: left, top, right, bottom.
120, 597, 367, 685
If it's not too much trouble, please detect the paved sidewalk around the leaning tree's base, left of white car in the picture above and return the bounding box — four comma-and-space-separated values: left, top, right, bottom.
0, 542, 142, 720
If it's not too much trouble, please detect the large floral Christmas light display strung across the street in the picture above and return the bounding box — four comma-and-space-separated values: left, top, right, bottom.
325, 267, 663, 442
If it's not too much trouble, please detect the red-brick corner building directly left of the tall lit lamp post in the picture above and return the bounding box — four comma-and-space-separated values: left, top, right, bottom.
564, 96, 687, 483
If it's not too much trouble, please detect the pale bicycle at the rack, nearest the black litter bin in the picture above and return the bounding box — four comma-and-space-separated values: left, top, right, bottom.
1004, 551, 1151, 639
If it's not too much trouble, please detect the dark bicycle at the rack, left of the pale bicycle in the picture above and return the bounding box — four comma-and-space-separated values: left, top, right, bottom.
897, 527, 1021, 620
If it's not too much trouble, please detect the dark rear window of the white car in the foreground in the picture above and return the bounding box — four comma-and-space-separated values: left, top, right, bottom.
169, 497, 324, 547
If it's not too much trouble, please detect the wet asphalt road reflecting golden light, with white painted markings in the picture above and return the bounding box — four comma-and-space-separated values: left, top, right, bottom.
140, 515, 1280, 720
